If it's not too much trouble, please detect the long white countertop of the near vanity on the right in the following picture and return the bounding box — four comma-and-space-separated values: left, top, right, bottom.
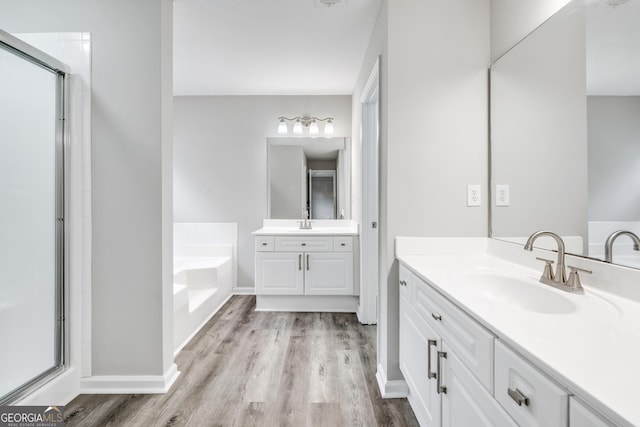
396, 238, 640, 425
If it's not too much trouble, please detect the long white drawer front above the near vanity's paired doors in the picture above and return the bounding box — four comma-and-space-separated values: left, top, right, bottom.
413, 276, 494, 393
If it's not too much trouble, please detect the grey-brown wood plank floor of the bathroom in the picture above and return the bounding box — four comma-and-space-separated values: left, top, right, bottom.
65, 296, 418, 427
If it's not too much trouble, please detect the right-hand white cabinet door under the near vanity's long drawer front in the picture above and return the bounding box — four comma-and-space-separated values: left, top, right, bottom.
438, 342, 517, 427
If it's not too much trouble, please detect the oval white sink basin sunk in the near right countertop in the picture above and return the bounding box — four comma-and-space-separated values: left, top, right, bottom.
461, 271, 578, 314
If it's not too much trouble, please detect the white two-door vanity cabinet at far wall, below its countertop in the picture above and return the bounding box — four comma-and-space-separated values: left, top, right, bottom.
256, 236, 354, 295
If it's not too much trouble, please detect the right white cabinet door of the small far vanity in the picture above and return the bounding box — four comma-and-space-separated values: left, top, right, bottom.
304, 252, 353, 295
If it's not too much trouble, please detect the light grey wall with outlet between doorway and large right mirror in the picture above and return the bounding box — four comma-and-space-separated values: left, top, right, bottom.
353, 0, 490, 380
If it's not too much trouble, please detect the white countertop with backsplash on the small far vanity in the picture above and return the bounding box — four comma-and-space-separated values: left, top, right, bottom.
252, 219, 358, 236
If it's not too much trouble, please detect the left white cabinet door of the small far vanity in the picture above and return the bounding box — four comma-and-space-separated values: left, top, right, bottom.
256, 252, 304, 295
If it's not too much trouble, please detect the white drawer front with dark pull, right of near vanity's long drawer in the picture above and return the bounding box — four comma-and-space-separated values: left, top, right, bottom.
494, 340, 569, 427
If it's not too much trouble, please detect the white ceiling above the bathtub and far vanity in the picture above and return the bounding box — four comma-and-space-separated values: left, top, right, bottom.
173, 0, 381, 95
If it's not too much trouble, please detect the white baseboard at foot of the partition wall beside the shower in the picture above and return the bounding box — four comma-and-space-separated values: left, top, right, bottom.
80, 363, 180, 394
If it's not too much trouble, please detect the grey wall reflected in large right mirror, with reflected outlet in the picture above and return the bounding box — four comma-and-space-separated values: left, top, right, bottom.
491, 5, 587, 241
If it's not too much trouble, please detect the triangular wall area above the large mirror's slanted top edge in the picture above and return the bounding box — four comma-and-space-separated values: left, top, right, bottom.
490, 0, 569, 62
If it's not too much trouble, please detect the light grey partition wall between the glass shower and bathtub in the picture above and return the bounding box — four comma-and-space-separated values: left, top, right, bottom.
0, 0, 173, 386
